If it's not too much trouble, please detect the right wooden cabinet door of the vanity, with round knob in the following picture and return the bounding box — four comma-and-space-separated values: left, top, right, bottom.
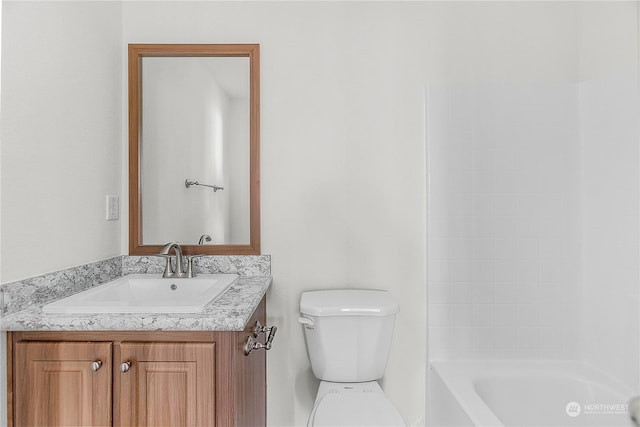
115, 342, 216, 427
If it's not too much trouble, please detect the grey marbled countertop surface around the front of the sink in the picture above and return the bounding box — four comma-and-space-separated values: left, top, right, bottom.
2, 276, 272, 331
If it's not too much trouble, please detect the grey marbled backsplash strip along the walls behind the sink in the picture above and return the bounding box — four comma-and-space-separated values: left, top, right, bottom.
0, 255, 271, 315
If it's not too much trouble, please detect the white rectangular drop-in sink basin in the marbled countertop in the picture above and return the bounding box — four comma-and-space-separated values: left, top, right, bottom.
42, 274, 238, 313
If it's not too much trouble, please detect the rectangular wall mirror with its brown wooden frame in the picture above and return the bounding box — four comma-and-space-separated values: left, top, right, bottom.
129, 44, 260, 255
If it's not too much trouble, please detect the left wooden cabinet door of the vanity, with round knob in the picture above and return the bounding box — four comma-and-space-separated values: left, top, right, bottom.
14, 342, 112, 427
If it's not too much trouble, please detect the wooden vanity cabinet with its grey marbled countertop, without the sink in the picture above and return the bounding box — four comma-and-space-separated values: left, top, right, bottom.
2, 259, 271, 427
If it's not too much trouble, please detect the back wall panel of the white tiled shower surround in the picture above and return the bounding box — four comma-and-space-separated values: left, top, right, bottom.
428, 85, 580, 359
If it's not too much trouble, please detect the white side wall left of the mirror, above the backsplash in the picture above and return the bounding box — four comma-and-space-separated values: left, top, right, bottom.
0, 1, 126, 283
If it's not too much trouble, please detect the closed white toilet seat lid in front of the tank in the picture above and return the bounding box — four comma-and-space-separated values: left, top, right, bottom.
308, 384, 406, 427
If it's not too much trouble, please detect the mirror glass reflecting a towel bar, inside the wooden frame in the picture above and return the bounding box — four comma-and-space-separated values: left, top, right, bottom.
140, 57, 249, 245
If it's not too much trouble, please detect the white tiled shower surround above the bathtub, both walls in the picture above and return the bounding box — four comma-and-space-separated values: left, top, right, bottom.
427, 72, 640, 388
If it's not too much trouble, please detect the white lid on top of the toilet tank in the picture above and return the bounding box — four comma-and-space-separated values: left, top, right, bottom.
300, 289, 399, 316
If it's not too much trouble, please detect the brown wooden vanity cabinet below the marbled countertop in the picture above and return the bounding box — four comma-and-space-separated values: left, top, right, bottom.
7, 300, 266, 427
